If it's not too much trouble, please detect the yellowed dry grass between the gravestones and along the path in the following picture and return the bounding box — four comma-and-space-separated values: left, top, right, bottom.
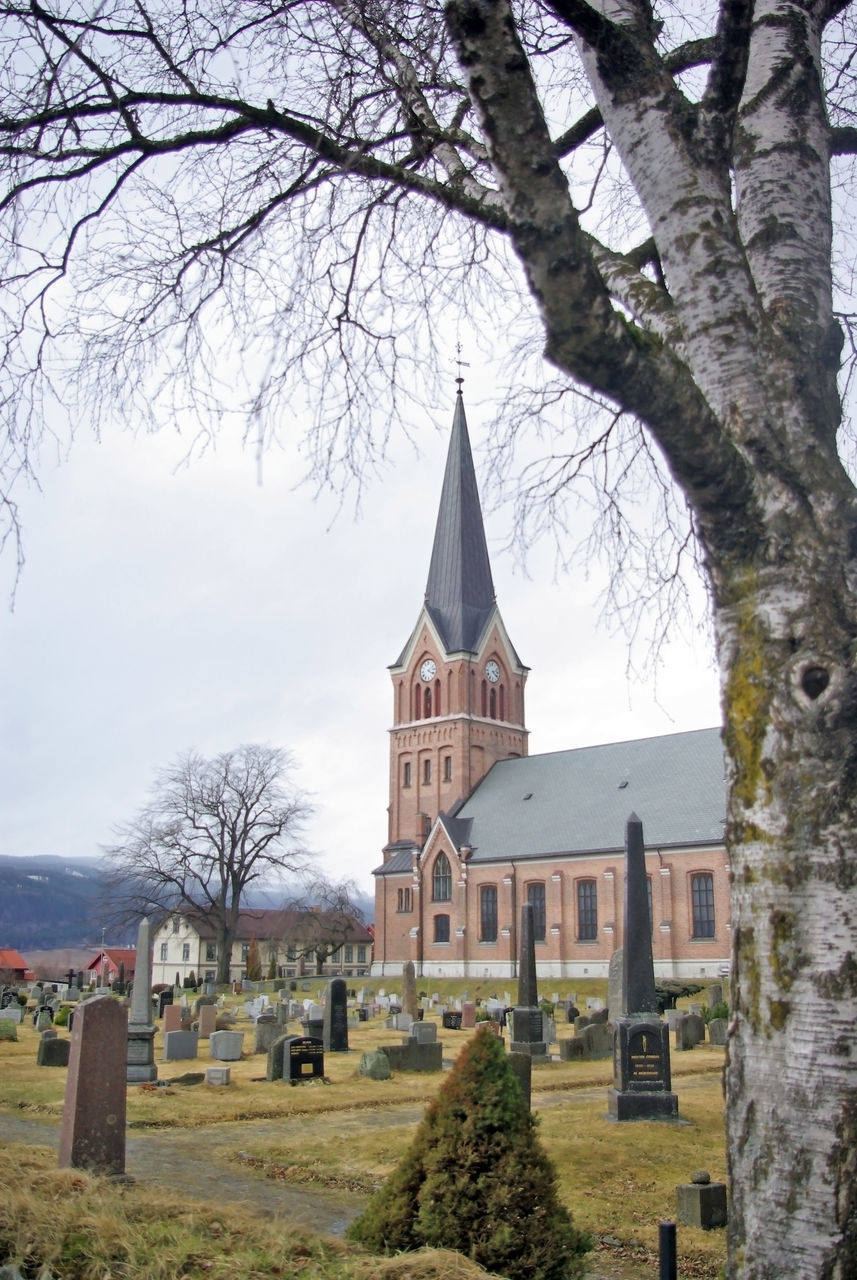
0, 983, 725, 1280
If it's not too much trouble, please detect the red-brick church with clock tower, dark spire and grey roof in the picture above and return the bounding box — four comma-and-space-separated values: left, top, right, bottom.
372, 380, 730, 980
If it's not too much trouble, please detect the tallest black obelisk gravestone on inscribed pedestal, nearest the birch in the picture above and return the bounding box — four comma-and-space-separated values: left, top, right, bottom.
608, 813, 678, 1120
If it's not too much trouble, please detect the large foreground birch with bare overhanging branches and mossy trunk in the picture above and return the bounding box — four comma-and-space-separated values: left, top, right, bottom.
0, 0, 857, 1277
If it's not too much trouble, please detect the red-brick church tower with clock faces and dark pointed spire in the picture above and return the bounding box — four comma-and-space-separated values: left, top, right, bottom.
384, 379, 528, 863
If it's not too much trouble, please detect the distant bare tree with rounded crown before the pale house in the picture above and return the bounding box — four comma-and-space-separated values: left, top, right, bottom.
105, 744, 312, 983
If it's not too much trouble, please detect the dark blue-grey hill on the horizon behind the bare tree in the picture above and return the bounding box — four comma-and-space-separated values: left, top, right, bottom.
0, 854, 375, 954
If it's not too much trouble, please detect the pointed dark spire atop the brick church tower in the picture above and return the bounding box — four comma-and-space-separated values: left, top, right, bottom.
426, 386, 495, 653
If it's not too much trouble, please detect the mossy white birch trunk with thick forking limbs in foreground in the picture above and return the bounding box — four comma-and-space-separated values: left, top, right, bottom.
449, 0, 857, 1280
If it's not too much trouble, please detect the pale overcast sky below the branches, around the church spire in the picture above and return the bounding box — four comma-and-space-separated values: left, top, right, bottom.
0, 363, 719, 892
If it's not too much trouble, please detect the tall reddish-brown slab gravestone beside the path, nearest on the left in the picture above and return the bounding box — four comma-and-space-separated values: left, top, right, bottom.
59, 996, 128, 1176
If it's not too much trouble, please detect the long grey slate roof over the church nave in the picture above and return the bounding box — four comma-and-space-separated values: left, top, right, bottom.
450, 728, 727, 863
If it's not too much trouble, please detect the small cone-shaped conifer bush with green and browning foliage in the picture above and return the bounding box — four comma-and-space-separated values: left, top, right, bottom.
348, 1029, 591, 1280
